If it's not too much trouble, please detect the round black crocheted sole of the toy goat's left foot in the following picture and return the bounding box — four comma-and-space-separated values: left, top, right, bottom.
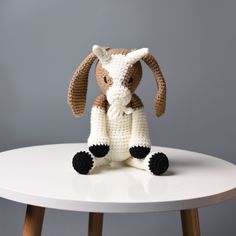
72, 152, 94, 175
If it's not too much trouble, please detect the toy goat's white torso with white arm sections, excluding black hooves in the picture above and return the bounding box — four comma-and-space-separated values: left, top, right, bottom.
88, 107, 151, 162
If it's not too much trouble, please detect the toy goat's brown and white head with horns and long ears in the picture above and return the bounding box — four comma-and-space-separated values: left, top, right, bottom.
68, 45, 166, 120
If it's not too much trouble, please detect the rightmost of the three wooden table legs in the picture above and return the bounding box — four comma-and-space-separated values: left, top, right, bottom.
180, 208, 201, 236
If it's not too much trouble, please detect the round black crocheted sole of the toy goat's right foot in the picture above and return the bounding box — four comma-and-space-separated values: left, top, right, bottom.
148, 152, 169, 175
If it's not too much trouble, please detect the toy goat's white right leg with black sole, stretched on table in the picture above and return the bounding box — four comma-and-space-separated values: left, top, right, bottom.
125, 152, 169, 175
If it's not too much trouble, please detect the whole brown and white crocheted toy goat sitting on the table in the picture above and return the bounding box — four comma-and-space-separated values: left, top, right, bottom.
68, 45, 169, 175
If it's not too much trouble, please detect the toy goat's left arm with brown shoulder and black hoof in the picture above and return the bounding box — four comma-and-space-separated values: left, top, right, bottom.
88, 94, 109, 157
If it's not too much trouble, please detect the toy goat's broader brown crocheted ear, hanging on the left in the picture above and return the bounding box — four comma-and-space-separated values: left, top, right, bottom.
67, 53, 97, 117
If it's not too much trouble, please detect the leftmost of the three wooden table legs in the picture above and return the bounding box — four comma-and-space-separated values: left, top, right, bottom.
23, 205, 45, 236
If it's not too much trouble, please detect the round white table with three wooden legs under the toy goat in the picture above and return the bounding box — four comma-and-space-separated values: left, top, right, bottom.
0, 144, 236, 236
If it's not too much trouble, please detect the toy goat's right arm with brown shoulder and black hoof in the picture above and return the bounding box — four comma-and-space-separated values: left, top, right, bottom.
129, 94, 151, 159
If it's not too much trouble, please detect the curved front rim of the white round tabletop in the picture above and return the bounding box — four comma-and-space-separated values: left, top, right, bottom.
0, 188, 236, 213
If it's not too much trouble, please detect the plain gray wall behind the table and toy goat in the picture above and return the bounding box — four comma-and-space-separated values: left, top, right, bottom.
0, 0, 236, 236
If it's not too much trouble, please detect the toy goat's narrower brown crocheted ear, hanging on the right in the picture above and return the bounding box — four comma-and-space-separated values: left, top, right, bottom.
142, 53, 166, 117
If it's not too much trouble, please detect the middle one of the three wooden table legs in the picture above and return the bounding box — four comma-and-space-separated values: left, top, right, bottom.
88, 212, 103, 236
